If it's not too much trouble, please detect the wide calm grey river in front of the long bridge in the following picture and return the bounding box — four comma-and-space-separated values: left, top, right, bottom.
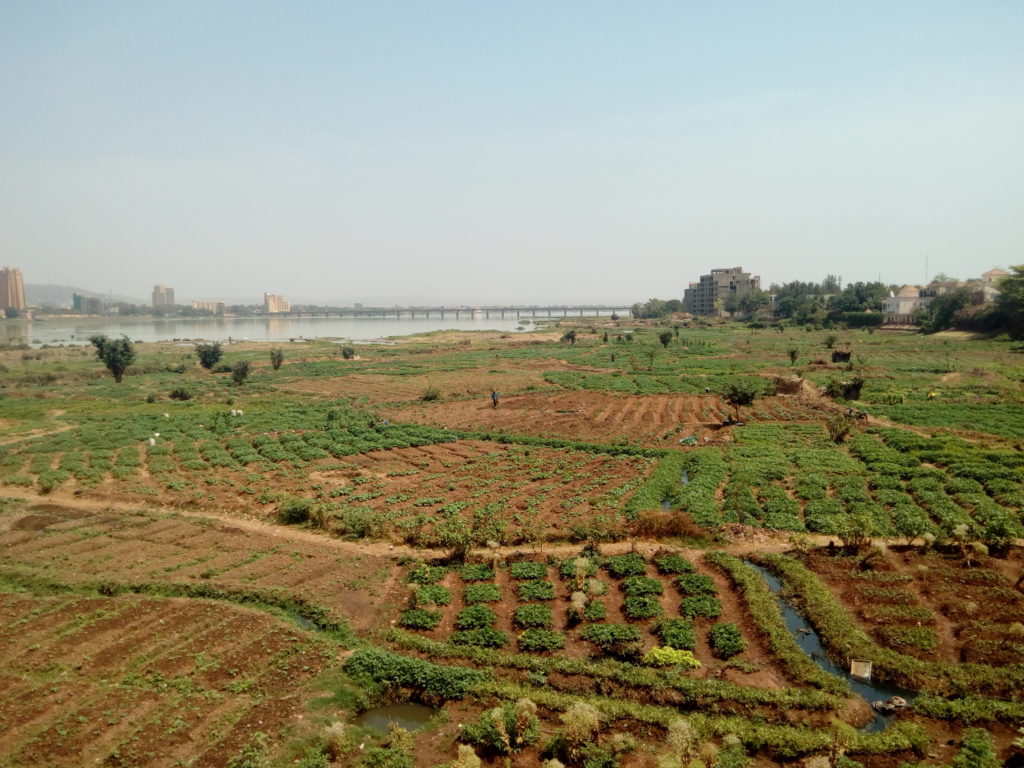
0, 312, 544, 347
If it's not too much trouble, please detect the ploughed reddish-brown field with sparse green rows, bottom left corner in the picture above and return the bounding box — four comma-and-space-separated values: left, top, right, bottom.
0, 594, 330, 768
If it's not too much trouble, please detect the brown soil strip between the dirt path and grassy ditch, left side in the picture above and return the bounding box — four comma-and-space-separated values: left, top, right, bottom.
0, 505, 395, 629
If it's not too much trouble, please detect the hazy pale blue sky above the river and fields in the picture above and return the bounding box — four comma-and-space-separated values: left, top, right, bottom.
0, 0, 1024, 302
